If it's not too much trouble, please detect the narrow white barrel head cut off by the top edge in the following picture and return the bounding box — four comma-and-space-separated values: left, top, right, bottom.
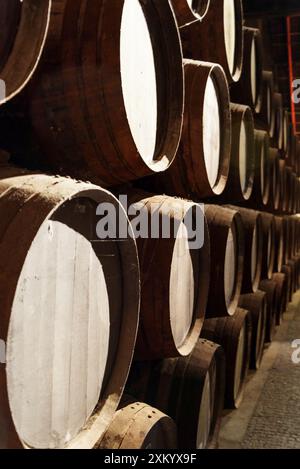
223, 0, 236, 74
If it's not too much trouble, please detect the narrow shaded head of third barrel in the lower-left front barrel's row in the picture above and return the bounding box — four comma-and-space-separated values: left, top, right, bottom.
224, 229, 237, 308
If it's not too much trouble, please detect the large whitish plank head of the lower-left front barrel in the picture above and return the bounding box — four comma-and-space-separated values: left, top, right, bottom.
7, 219, 110, 448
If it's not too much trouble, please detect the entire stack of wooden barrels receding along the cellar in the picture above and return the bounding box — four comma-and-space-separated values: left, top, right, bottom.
0, 0, 300, 449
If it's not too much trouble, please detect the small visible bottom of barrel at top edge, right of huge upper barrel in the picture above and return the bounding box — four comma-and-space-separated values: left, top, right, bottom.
171, 0, 210, 28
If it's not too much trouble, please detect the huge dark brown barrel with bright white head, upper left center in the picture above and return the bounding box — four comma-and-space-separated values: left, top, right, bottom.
18, 0, 184, 187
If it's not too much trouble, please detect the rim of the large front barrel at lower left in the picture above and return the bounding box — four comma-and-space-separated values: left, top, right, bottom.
0, 170, 140, 448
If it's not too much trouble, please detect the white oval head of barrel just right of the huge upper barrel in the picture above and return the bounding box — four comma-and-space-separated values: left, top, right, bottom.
203, 76, 221, 188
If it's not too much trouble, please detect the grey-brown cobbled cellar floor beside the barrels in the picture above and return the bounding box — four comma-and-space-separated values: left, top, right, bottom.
220, 292, 300, 449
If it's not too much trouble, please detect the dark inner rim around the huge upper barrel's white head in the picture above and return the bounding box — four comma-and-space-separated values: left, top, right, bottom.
118, 0, 184, 173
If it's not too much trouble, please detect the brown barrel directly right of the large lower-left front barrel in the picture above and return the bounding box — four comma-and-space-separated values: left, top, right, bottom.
128, 192, 210, 360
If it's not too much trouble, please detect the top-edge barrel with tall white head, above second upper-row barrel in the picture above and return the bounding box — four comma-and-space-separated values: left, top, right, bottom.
180, 0, 244, 83
